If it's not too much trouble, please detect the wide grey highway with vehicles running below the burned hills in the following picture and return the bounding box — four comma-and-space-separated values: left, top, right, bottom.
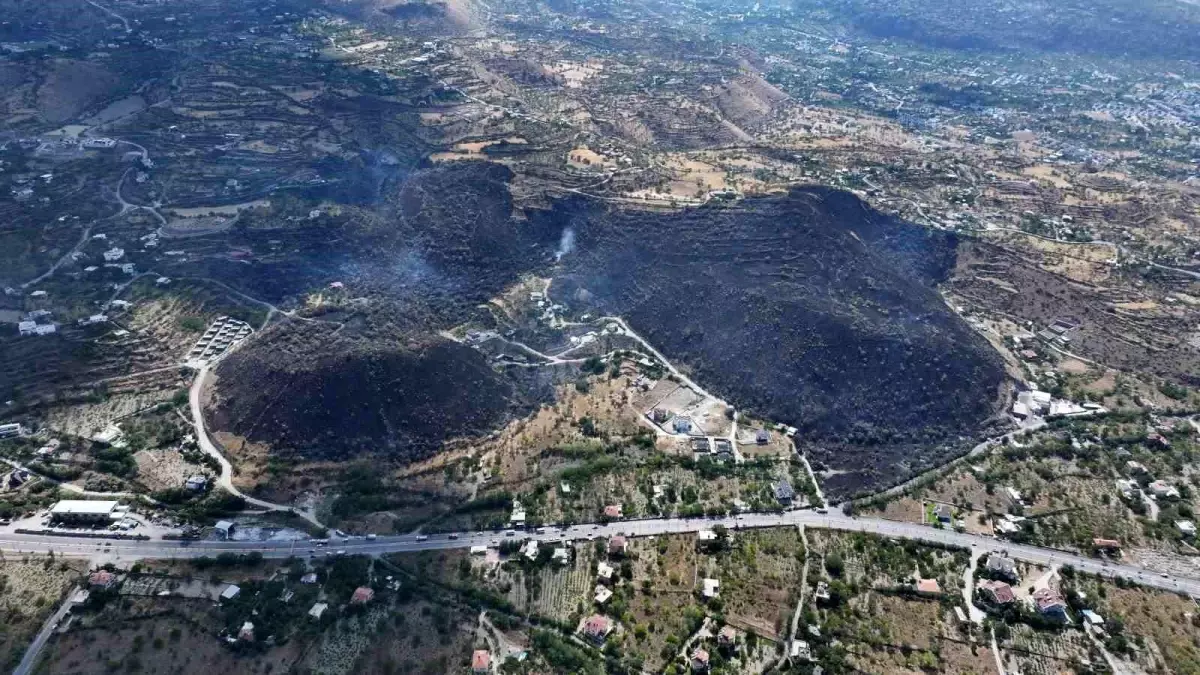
0, 510, 1200, 597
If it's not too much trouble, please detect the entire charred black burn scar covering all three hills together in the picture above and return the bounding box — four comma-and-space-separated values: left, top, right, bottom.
206, 163, 1003, 491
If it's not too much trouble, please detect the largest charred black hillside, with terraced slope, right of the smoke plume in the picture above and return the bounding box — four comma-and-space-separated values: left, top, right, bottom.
553, 190, 1003, 490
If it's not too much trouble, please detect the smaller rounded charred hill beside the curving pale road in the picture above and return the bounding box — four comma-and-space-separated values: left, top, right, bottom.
209, 322, 552, 460
